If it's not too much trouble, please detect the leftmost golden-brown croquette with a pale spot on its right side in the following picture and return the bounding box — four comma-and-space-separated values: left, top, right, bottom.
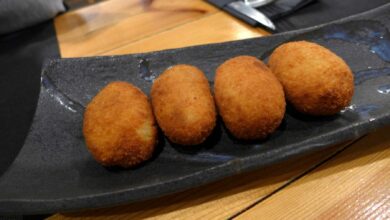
83, 82, 157, 168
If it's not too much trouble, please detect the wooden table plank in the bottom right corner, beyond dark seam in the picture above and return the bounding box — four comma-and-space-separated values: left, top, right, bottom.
237, 127, 390, 219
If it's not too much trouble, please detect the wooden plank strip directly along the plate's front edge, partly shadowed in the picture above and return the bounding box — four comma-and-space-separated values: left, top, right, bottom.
49, 143, 354, 220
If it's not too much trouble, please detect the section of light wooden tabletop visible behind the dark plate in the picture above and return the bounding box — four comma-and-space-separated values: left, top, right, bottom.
55, 0, 268, 57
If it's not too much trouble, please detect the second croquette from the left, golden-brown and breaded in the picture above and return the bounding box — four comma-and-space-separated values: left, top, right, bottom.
151, 65, 216, 145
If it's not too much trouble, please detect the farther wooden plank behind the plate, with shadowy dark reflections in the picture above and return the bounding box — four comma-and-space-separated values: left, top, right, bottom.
55, 0, 217, 57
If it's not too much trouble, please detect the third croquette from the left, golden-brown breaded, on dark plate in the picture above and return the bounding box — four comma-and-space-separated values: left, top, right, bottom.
214, 56, 286, 140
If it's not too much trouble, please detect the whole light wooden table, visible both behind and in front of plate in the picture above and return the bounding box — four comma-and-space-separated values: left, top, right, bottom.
49, 0, 390, 219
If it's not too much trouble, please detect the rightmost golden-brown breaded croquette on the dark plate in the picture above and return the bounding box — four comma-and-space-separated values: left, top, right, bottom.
269, 41, 354, 115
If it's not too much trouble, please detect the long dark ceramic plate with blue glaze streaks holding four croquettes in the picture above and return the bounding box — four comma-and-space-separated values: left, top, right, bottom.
0, 5, 390, 213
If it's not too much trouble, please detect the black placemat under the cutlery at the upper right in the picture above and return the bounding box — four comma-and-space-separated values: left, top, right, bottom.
207, 0, 389, 32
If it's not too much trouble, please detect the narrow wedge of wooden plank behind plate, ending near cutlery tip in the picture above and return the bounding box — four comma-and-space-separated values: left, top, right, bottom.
102, 12, 269, 55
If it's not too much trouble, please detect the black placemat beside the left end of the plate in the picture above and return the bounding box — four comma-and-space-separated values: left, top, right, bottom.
0, 21, 60, 178
